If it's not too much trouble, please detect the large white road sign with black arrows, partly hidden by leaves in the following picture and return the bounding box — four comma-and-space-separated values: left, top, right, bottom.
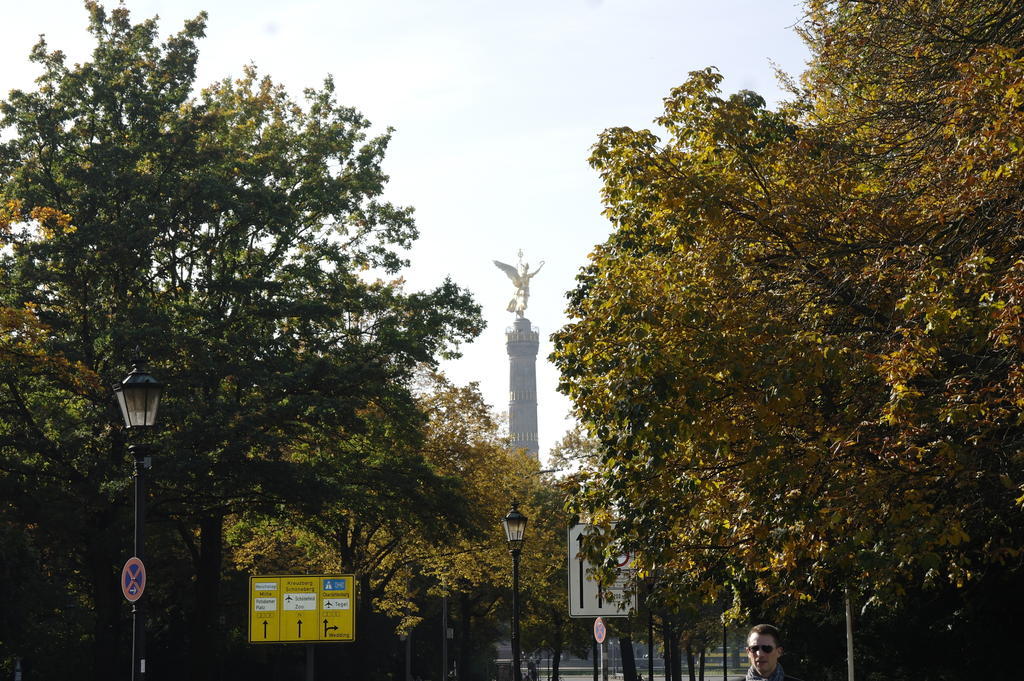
568, 523, 637, 618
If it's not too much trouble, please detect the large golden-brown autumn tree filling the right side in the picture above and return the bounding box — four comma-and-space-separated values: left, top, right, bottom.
554, 0, 1024, 678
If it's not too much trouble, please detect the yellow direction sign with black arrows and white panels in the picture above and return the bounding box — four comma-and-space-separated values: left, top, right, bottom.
249, 574, 355, 643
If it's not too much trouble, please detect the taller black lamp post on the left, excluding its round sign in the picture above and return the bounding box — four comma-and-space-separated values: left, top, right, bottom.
114, 365, 164, 681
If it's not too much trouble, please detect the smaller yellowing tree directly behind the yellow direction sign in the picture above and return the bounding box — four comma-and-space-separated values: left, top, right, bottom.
223, 372, 536, 679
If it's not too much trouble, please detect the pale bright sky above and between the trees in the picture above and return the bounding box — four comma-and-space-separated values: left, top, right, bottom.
0, 0, 808, 461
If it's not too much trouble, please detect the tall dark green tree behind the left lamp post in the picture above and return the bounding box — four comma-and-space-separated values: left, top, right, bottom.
0, 2, 480, 678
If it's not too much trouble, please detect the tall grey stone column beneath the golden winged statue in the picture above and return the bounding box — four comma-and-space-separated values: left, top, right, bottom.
505, 316, 541, 459
